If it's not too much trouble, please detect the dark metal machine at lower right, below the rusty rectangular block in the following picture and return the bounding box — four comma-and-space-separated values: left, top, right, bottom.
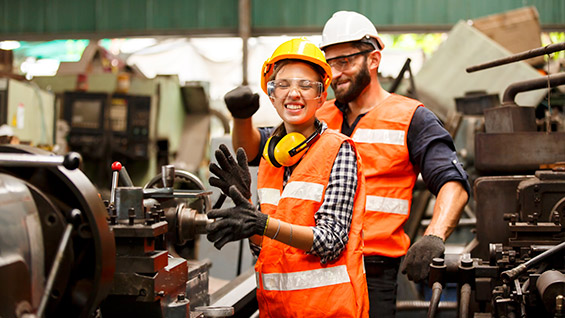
428, 167, 565, 318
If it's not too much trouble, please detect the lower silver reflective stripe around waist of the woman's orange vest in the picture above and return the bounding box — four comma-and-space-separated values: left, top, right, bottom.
262, 265, 349, 291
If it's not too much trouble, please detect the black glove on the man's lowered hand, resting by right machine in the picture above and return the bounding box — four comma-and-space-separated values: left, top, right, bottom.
400, 235, 445, 283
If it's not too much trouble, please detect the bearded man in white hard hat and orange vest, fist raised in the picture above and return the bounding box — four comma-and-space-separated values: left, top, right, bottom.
225, 11, 470, 317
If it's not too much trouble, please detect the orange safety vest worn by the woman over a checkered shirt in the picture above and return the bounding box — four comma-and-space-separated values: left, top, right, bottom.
255, 129, 369, 317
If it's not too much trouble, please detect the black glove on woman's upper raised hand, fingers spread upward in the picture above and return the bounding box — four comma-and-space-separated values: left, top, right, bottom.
208, 144, 251, 200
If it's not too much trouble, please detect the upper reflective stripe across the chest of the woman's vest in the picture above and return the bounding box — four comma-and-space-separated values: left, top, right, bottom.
257, 181, 324, 205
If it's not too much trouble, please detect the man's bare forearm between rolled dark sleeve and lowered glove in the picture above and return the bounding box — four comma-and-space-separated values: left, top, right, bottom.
424, 181, 469, 241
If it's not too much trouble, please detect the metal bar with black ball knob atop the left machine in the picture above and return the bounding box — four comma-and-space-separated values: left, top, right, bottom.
0, 152, 81, 170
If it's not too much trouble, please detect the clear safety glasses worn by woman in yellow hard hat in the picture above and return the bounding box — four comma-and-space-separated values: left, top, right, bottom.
267, 78, 324, 100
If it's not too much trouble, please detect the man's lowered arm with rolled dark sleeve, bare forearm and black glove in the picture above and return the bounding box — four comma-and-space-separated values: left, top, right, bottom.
400, 107, 470, 282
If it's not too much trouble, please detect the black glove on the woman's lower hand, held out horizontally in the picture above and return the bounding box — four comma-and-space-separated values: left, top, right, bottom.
206, 185, 268, 249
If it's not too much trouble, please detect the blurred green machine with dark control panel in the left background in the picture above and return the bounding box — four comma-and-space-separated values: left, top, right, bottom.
33, 73, 185, 192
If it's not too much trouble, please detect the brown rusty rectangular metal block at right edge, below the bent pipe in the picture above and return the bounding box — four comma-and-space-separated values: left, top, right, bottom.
475, 132, 565, 174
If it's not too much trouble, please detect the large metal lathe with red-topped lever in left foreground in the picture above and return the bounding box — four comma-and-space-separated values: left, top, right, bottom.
0, 145, 234, 318
